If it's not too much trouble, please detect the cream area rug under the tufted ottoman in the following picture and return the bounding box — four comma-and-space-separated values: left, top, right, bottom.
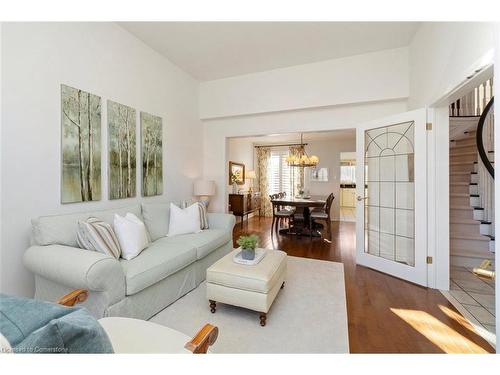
151, 256, 349, 353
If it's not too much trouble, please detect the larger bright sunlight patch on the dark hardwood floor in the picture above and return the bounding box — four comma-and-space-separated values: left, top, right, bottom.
391, 308, 487, 353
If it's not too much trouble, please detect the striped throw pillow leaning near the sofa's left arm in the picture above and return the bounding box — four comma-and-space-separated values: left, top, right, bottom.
76, 217, 122, 259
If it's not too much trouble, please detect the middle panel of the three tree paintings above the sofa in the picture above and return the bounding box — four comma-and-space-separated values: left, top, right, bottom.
108, 100, 136, 199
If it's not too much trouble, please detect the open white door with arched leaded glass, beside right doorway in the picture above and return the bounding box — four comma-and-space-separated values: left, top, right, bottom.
356, 109, 427, 285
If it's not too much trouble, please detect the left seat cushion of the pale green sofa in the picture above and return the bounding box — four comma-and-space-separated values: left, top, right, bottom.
120, 237, 196, 296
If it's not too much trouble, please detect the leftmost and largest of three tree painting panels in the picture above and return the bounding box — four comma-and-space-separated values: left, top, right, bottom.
61, 85, 101, 203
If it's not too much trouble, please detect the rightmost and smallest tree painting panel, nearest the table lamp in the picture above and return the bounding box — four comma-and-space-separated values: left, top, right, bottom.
141, 112, 163, 197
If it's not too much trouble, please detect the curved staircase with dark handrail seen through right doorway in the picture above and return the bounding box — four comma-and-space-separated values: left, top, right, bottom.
450, 82, 495, 267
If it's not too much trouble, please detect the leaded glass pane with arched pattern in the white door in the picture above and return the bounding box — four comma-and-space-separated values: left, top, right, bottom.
365, 121, 415, 267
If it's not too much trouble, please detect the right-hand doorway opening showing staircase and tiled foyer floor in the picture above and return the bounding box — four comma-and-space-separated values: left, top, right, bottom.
443, 74, 496, 346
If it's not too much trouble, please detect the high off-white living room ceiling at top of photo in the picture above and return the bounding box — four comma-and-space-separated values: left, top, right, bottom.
119, 22, 419, 81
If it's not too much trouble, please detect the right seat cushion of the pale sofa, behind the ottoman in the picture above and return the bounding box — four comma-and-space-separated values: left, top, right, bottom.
161, 229, 231, 259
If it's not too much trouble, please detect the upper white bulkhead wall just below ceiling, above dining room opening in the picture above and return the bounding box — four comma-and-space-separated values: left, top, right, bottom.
200, 47, 409, 119
